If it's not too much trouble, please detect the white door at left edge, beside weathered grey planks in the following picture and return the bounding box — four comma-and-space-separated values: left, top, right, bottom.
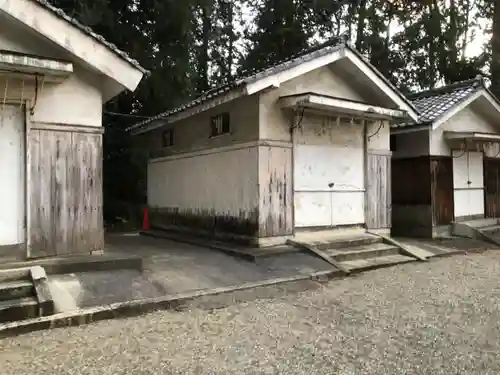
0, 105, 25, 246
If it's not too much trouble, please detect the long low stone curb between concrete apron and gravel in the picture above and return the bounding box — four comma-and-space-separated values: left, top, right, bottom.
0, 270, 342, 338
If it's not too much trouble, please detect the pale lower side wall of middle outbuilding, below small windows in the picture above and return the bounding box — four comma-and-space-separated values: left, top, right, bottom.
147, 146, 259, 217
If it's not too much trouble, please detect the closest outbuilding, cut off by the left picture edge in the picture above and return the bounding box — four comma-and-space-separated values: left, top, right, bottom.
0, 0, 146, 260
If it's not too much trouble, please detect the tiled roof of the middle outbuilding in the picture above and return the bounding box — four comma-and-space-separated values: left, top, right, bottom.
128, 36, 411, 130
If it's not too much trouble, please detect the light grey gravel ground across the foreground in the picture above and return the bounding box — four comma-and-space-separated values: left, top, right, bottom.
0, 251, 500, 375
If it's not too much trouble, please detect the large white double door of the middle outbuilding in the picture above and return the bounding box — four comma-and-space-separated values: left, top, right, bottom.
294, 144, 365, 227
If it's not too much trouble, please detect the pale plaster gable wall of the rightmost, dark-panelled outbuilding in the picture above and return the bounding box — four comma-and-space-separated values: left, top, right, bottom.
430, 106, 498, 156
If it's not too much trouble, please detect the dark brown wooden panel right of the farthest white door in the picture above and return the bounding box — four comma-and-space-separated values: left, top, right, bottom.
484, 158, 500, 218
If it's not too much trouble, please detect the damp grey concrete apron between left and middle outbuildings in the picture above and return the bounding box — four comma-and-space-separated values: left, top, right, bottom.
43, 233, 341, 313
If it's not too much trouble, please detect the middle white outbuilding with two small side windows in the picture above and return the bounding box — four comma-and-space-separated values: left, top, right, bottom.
129, 40, 418, 246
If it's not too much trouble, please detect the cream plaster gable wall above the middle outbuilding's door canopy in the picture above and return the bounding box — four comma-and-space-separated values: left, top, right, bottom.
259, 66, 362, 141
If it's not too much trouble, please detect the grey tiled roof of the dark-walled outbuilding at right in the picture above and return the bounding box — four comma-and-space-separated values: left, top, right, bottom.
395, 77, 485, 127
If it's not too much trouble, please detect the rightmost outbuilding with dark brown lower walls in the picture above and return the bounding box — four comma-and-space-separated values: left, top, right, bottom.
391, 77, 500, 237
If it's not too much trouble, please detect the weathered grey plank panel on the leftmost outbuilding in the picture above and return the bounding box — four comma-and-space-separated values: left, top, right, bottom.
28, 128, 104, 258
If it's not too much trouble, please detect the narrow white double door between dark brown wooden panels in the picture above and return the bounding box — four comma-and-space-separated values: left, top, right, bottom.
452, 151, 484, 218
